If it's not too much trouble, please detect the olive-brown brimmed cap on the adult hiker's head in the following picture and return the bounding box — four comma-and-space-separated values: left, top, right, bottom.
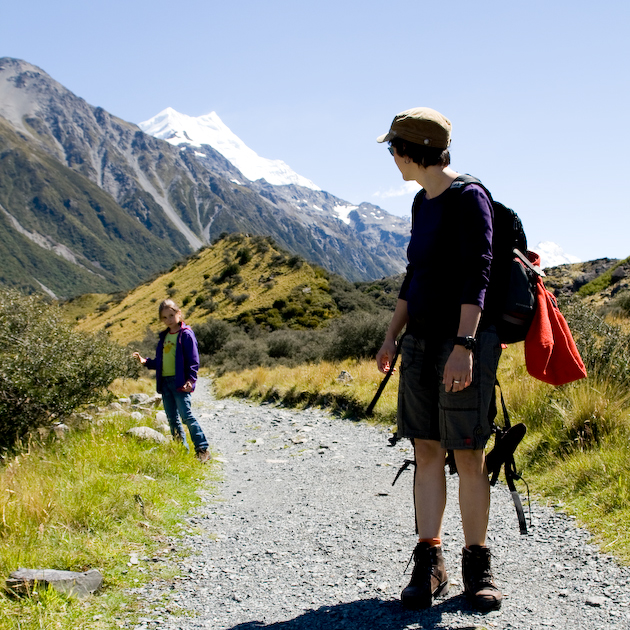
376, 107, 452, 149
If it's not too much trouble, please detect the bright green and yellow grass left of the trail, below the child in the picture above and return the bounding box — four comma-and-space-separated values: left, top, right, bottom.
0, 414, 218, 630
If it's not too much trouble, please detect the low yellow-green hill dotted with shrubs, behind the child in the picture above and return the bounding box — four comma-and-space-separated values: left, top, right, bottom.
73, 234, 382, 343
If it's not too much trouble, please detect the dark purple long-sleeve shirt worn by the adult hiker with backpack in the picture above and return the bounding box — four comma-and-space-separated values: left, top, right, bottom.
399, 184, 494, 337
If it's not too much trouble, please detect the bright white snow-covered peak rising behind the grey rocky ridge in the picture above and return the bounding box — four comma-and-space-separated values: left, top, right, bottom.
138, 107, 321, 190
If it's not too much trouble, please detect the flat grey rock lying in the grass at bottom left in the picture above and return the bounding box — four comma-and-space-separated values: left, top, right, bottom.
6, 569, 103, 597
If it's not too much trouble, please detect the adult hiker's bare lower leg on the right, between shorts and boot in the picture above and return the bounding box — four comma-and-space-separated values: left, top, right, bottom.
454, 450, 490, 547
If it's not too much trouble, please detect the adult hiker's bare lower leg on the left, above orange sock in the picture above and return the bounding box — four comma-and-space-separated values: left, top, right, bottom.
414, 439, 446, 539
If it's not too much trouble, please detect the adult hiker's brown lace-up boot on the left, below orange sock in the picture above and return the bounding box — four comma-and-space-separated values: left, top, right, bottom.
400, 543, 448, 610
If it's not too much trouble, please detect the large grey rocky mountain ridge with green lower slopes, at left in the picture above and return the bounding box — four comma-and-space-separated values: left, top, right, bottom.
0, 58, 409, 296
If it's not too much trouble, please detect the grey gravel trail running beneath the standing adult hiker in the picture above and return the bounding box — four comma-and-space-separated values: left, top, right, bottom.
134, 379, 630, 630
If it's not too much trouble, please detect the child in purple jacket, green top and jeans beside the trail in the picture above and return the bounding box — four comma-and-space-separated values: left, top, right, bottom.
133, 300, 210, 463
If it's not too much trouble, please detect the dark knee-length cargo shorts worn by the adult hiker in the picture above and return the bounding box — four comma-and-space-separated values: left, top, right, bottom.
398, 327, 501, 450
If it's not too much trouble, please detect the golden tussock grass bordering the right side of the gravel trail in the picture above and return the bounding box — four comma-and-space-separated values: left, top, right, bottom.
215, 344, 630, 562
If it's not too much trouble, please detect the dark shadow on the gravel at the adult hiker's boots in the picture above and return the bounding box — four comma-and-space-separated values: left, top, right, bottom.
225, 595, 492, 630
